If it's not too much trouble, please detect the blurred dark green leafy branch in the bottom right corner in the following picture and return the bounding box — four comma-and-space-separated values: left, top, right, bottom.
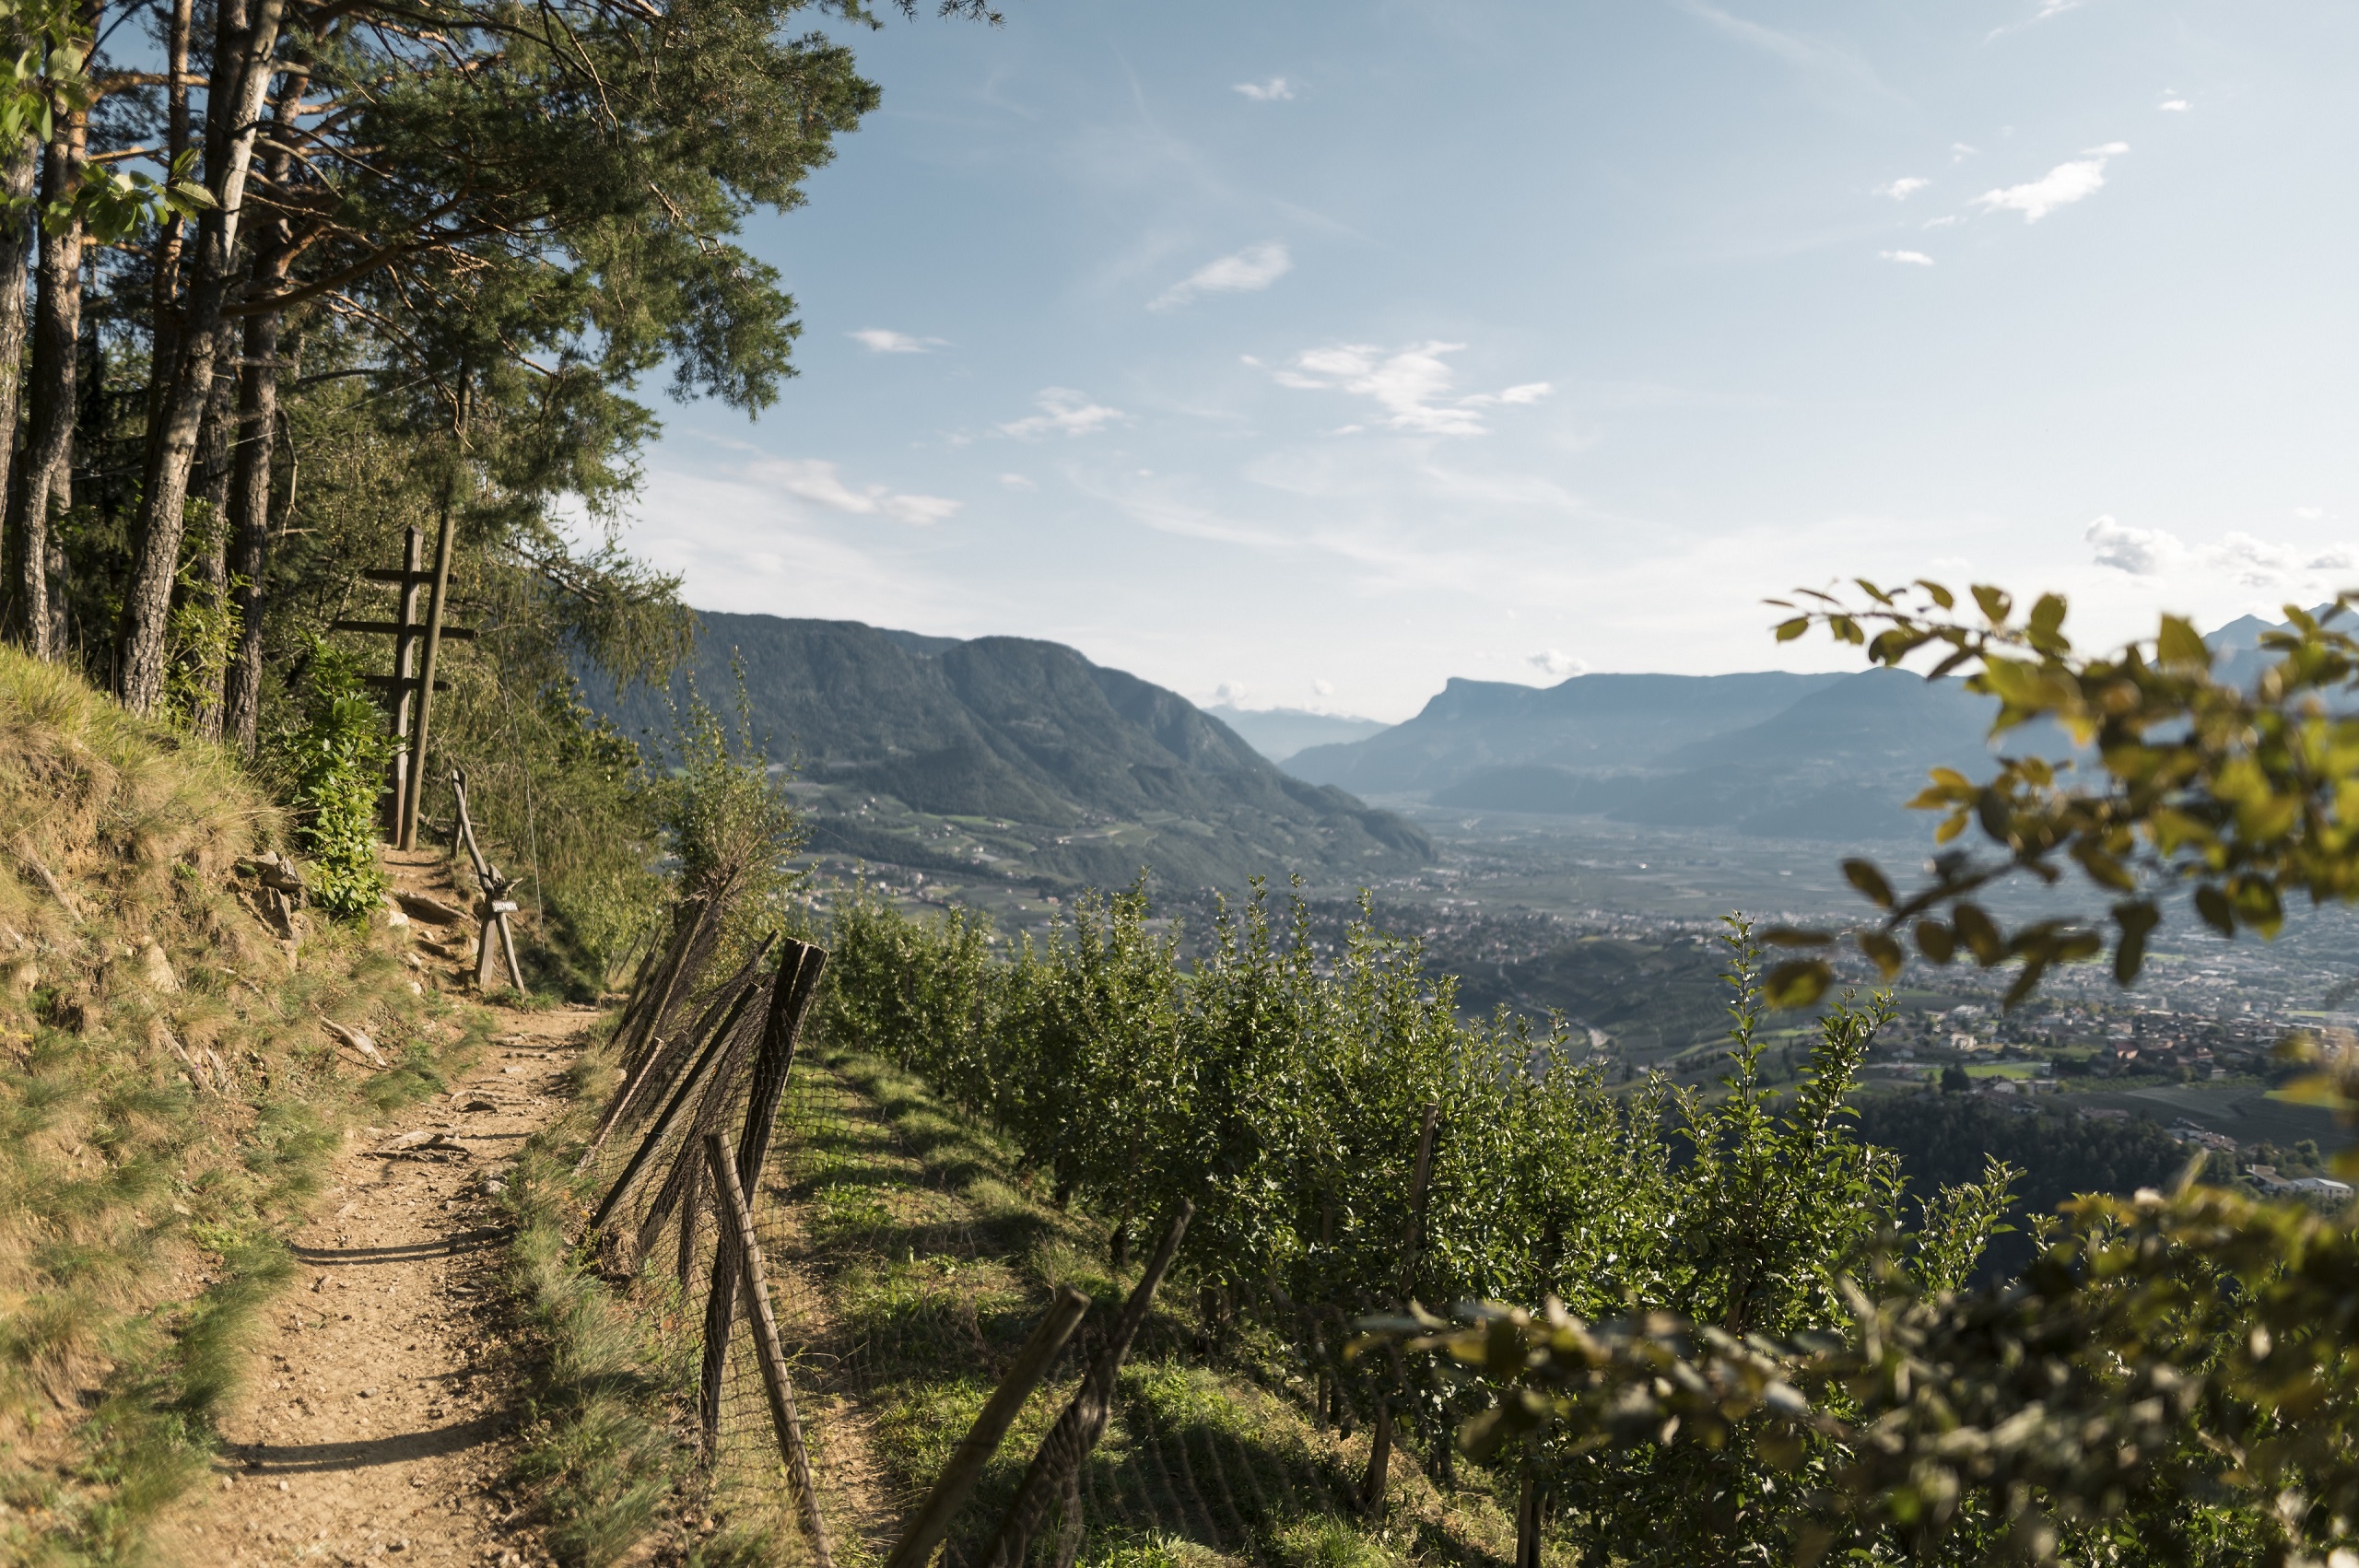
1356, 1167, 2359, 1565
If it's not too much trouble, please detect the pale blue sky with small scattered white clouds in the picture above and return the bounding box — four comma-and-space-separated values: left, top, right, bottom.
623, 0, 2359, 720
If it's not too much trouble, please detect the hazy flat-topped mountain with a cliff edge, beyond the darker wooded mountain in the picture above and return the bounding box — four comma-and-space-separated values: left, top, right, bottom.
1285, 670, 1847, 795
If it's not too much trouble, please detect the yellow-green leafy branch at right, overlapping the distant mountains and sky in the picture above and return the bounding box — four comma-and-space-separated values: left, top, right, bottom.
1765, 578, 2359, 1007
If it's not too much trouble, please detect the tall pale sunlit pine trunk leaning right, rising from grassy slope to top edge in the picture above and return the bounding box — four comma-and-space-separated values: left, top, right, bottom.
115, 0, 286, 712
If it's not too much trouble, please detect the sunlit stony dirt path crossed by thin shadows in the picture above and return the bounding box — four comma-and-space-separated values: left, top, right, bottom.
156, 1009, 593, 1568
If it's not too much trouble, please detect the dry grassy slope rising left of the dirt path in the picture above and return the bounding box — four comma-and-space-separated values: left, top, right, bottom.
0, 650, 479, 1563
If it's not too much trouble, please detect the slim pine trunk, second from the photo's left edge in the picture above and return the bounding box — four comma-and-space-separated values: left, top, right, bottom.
9, 109, 89, 658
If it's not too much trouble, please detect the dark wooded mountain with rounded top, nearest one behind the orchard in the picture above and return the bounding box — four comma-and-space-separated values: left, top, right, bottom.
593, 611, 1432, 886
